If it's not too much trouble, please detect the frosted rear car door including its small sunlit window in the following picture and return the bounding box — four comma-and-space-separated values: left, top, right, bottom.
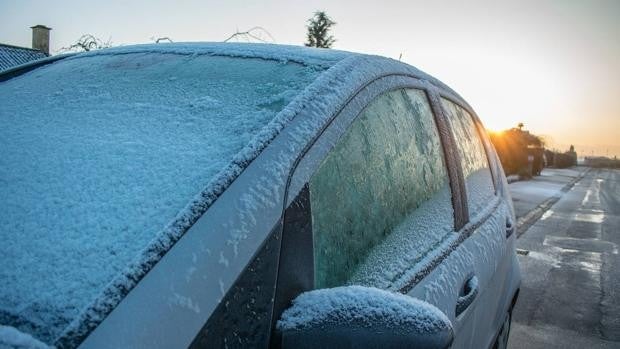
441, 98, 514, 348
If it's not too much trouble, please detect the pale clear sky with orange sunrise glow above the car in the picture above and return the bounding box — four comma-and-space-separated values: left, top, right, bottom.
0, 0, 620, 157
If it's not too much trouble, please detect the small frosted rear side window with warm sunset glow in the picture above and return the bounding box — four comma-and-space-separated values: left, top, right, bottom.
441, 99, 495, 217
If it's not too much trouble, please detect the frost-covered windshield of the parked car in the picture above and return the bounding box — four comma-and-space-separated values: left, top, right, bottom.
0, 53, 322, 344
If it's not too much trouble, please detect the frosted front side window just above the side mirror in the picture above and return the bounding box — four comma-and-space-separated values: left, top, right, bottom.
309, 89, 454, 288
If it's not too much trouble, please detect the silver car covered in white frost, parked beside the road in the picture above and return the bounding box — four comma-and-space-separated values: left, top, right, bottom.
0, 43, 520, 348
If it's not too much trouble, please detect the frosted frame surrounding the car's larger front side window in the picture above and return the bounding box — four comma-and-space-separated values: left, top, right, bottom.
273, 74, 467, 304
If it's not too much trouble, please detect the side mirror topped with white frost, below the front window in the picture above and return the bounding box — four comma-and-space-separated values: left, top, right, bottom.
277, 286, 454, 349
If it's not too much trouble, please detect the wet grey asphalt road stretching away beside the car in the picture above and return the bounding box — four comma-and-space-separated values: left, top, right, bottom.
509, 168, 620, 349
